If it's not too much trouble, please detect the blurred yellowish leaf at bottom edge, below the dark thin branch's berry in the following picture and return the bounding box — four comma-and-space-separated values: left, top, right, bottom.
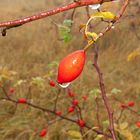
67, 130, 82, 139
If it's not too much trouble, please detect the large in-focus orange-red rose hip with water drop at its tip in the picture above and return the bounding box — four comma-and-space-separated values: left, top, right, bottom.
57, 50, 86, 84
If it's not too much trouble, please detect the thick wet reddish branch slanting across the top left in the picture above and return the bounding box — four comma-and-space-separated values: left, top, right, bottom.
0, 0, 115, 28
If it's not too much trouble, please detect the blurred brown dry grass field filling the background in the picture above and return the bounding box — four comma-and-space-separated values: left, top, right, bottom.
0, 0, 140, 140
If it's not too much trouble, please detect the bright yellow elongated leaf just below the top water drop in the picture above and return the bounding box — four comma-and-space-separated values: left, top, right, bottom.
91, 12, 115, 19
